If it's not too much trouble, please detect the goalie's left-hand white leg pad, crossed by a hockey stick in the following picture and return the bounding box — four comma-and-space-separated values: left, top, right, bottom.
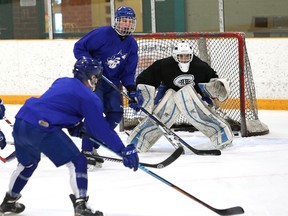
127, 89, 180, 152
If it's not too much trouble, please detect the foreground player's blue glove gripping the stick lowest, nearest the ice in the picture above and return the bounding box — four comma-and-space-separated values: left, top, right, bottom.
121, 144, 139, 171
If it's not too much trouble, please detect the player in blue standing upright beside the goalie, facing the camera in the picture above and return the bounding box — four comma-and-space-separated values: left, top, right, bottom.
74, 7, 138, 169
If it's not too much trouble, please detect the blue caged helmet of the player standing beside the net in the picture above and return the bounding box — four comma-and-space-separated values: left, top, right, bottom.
113, 7, 136, 36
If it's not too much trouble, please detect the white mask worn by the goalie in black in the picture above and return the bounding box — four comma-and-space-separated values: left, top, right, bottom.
172, 42, 193, 73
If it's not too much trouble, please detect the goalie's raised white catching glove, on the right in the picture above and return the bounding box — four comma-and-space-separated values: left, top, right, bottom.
198, 78, 231, 102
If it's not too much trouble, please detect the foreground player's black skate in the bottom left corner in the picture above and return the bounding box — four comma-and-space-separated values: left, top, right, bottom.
0, 193, 25, 215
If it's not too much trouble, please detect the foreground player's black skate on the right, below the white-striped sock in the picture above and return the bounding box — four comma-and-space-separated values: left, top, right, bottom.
69, 194, 103, 216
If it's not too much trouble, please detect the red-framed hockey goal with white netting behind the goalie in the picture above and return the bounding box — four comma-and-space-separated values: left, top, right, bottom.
120, 32, 269, 137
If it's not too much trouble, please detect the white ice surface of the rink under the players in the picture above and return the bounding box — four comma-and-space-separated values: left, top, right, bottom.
0, 105, 288, 216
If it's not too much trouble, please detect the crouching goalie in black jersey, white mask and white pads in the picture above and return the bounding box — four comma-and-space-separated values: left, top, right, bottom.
127, 42, 233, 152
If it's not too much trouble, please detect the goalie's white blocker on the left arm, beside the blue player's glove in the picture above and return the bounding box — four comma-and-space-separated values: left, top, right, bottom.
137, 84, 155, 113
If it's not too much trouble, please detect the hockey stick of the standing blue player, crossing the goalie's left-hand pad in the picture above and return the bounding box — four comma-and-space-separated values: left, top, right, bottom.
102, 75, 221, 155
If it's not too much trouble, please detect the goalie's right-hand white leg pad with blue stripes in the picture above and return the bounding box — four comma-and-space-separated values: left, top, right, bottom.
174, 85, 233, 148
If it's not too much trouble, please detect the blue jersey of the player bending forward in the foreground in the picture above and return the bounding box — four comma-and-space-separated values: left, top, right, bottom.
16, 77, 125, 152
